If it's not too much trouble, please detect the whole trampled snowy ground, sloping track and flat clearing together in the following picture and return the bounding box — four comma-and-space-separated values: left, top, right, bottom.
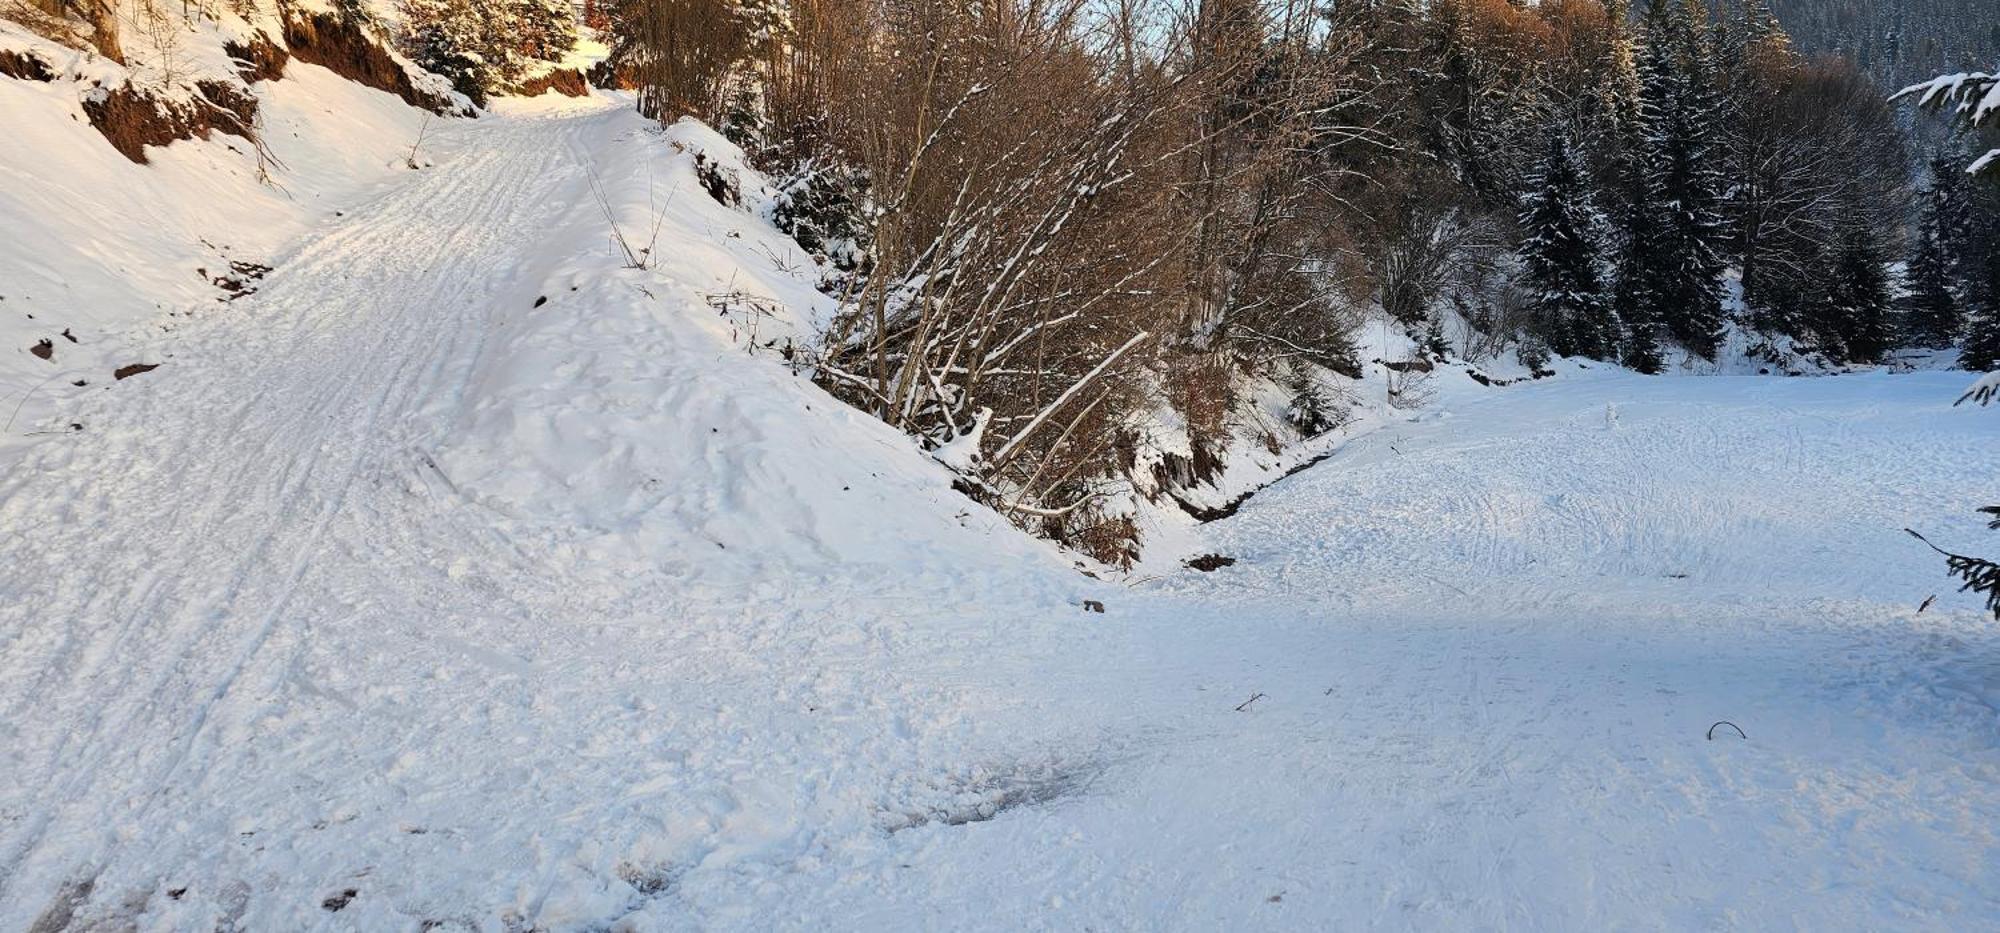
0, 100, 2000, 929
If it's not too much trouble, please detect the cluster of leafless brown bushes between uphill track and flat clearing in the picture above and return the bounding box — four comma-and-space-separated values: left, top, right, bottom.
622, 0, 1382, 555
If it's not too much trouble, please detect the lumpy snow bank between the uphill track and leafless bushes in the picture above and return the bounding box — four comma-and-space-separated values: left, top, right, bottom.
436, 102, 1058, 587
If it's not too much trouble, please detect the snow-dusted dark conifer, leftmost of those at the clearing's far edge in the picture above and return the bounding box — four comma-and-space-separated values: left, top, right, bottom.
1520, 130, 1618, 360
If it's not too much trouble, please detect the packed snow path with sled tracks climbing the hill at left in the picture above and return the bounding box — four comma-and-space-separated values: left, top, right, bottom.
0, 109, 600, 925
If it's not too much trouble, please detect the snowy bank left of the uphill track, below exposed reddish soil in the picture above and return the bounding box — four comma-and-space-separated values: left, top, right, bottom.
0, 62, 460, 446
